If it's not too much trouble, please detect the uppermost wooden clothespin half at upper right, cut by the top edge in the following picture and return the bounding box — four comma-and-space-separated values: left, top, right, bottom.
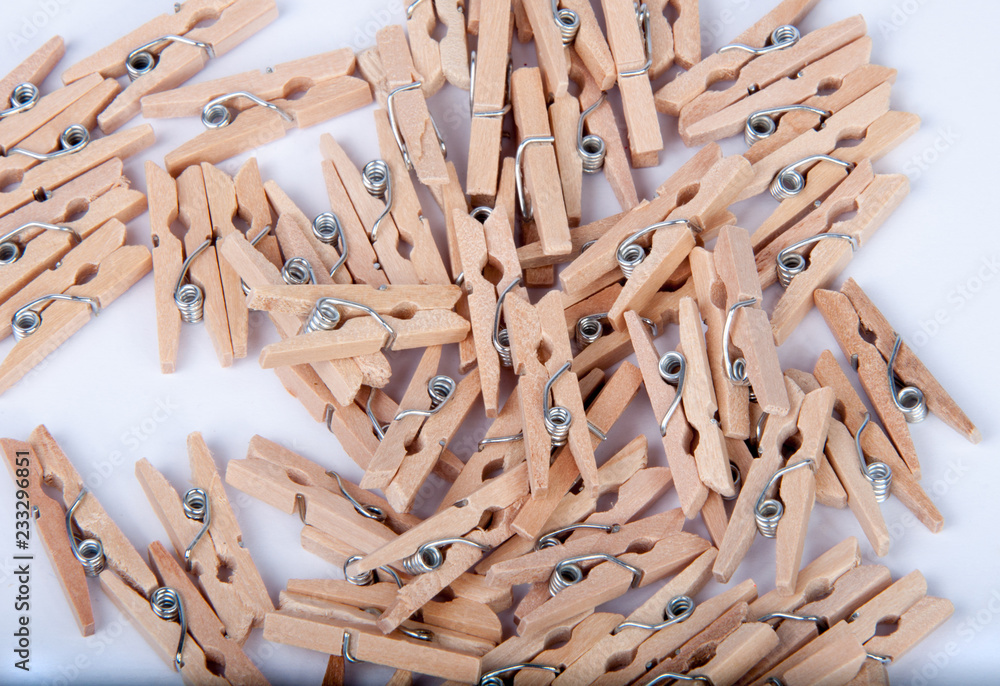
656, 0, 817, 117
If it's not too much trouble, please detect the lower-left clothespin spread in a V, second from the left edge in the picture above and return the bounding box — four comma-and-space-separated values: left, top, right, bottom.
136, 433, 274, 643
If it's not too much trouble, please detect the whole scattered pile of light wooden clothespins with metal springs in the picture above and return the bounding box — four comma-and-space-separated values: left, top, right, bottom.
0, 0, 980, 686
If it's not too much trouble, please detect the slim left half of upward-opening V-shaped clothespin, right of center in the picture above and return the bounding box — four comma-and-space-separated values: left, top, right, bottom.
625, 311, 708, 519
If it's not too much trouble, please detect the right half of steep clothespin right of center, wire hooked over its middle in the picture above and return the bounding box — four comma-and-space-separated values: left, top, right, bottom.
715, 226, 789, 415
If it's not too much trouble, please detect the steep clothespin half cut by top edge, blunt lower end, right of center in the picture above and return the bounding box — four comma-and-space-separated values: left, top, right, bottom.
601, 0, 663, 167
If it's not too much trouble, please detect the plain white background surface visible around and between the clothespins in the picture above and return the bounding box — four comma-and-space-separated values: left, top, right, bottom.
0, 0, 1000, 686
